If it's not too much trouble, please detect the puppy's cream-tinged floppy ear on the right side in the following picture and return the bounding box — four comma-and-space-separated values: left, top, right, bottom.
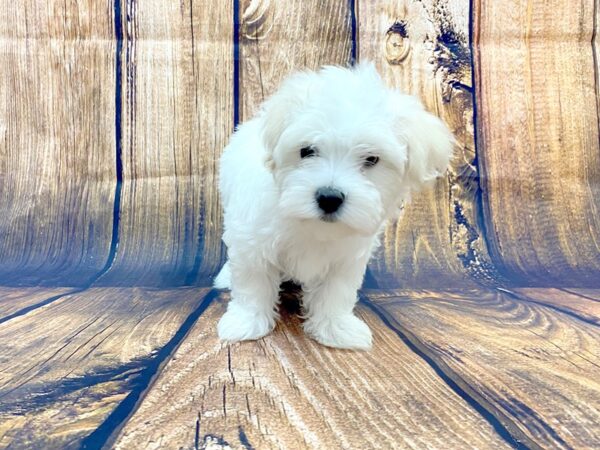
390, 92, 455, 192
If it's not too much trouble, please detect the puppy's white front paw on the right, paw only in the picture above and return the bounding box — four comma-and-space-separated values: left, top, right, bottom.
304, 314, 372, 350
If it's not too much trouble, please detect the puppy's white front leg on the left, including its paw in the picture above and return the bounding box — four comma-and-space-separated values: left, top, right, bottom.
217, 264, 280, 342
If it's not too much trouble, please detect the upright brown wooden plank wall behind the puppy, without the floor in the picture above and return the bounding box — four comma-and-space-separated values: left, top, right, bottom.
0, 0, 600, 287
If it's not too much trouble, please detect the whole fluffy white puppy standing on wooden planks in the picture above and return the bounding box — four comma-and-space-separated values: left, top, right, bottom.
215, 64, 453, 349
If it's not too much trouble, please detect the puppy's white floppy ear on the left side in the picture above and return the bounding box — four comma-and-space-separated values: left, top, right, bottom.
260, 72, 314, 169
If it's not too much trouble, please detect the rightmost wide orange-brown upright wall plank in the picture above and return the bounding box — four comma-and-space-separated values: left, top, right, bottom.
474, 0, 600, 287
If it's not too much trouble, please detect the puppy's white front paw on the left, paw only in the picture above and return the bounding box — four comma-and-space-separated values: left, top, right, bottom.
217, 302, 275, 342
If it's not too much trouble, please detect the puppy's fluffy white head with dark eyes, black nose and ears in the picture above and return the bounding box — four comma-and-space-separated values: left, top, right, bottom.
260, 64, 453, 239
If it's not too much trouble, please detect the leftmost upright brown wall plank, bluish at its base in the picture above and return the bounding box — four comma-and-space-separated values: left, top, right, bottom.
0, 0, 115, 284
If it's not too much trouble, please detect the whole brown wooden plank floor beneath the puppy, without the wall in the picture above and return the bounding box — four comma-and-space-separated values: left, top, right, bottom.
0, 288, 600, 449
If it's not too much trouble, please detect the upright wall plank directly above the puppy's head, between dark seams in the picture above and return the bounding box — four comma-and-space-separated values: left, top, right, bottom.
238, 0, 352, 121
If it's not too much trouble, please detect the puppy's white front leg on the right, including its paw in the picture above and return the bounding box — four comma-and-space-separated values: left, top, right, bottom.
303, 267, 372, 350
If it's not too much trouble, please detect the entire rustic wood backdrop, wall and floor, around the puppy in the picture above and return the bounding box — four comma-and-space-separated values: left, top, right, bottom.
0, 0, 600, 449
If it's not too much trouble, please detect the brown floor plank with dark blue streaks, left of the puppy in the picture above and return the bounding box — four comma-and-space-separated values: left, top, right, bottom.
0, 288, 211, 449
